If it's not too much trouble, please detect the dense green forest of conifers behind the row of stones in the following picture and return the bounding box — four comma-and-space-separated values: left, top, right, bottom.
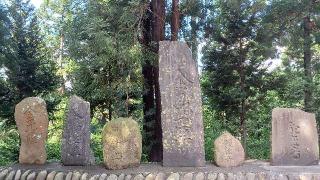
0, 0, 320, 165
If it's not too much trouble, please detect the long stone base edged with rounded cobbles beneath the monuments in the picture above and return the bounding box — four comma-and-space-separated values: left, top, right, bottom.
0, 161, 320, 180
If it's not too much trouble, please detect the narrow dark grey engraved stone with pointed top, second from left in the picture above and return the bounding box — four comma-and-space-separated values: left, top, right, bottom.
61, 96, 94, 166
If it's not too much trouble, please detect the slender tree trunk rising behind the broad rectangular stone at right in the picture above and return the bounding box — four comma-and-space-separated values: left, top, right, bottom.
303, 16, 313, 112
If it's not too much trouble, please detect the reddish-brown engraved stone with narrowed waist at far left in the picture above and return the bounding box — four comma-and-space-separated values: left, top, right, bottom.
14, 97, 49, 164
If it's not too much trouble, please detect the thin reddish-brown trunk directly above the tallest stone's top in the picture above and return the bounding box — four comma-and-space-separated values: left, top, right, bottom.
171, 0, 180, 41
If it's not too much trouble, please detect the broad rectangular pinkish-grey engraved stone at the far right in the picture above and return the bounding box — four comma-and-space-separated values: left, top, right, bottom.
271, 108, 319, 166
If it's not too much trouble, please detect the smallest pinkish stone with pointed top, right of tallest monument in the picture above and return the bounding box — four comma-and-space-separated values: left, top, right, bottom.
214, 132, 245, 167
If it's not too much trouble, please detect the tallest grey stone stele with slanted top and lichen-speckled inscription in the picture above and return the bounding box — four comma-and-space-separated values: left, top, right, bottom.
159, 41, 205, 167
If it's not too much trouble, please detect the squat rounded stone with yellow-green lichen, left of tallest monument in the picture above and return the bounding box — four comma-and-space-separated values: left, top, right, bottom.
102, 118, 142, 169
